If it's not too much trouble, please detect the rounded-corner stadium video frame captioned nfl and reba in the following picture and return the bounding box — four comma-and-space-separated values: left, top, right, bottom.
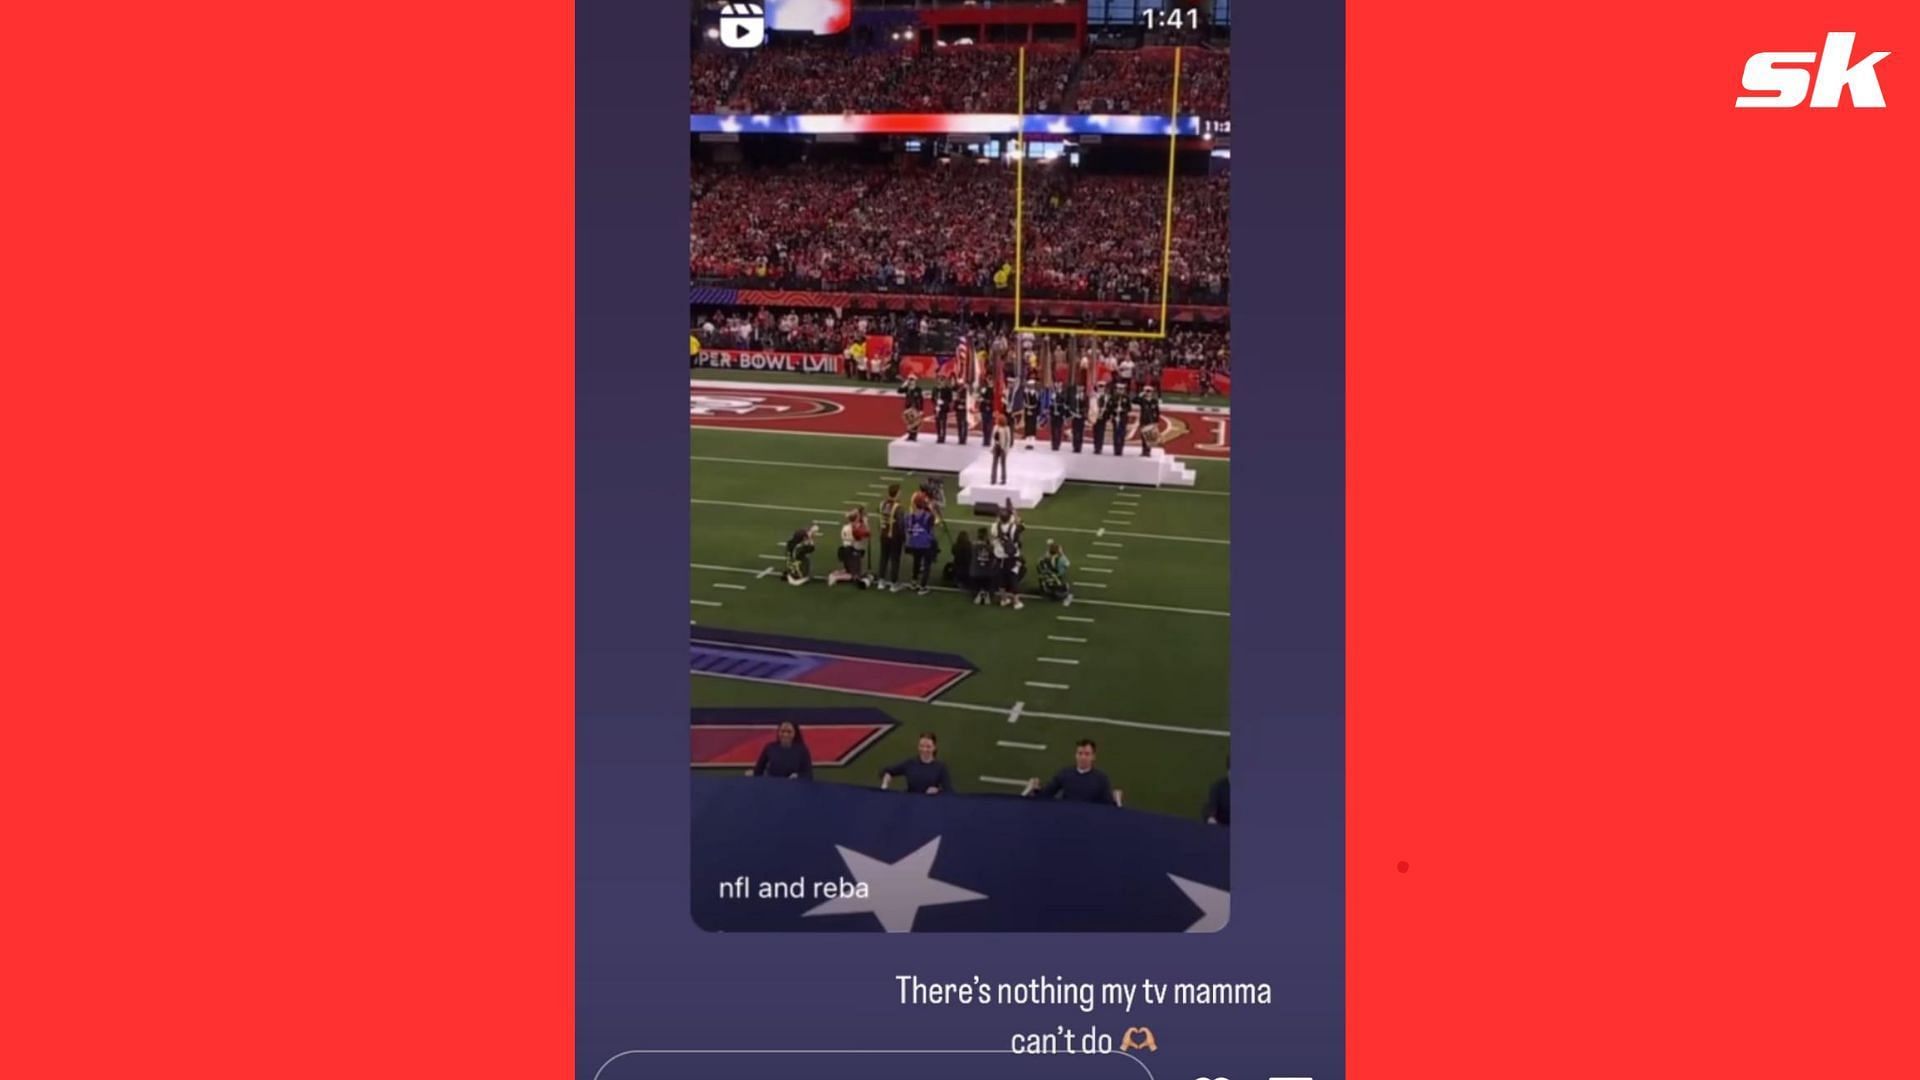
689, 0, 1233, 930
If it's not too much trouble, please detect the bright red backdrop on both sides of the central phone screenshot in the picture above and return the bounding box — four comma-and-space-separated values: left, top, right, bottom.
0, 0, 1920, 1078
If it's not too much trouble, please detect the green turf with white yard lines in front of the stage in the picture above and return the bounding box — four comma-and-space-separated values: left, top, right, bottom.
689, 427, 1231, 817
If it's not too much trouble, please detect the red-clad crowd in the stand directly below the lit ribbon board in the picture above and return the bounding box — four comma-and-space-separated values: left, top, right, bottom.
689, 160, 1231, 304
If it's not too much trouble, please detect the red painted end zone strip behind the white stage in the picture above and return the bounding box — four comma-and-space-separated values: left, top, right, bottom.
689, 379, 1233, 457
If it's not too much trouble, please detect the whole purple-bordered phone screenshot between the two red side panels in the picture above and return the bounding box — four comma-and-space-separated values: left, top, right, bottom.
580, 0, 1342, 1080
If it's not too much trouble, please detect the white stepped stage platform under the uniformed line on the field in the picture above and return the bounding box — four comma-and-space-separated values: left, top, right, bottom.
887, 432, 1196, 509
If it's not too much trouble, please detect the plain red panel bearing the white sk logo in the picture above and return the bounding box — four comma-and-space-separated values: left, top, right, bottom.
1348, 0, 1920, 1078
